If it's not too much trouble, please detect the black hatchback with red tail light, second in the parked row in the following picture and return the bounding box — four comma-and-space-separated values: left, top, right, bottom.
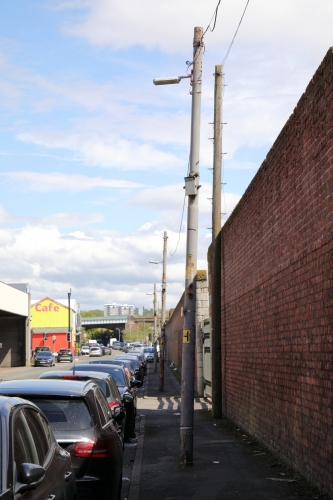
0, 379, 123, 500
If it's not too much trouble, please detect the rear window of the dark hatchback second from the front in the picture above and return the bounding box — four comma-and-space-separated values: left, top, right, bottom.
29, 398, 94, 431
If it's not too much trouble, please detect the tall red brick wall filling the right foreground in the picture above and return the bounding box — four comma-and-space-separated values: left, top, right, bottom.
222, 49, 333, 498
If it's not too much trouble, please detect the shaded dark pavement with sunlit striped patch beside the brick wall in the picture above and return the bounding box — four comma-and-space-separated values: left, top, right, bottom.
128, 364, 327, 500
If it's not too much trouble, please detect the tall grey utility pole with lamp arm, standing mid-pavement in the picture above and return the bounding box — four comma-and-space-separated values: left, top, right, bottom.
180, 27, 203, 467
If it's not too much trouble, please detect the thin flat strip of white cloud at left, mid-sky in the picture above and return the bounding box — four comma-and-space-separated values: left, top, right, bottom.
0, 172, 145, 193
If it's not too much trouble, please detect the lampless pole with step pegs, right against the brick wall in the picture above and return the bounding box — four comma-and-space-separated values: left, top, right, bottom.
211, 65, 223, 418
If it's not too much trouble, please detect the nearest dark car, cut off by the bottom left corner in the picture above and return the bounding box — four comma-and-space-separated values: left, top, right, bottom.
0, 396, 76, 500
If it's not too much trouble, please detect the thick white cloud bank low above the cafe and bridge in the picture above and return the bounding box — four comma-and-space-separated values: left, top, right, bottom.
0, 226, 192, 307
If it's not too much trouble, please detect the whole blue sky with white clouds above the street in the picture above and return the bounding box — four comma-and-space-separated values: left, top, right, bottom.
0, 0, 333, 309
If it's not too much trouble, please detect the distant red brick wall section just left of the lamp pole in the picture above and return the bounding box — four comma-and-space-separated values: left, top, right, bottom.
165, 294, 184, 370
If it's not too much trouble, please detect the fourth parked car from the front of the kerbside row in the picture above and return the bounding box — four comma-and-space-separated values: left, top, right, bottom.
71, 363, 137, 440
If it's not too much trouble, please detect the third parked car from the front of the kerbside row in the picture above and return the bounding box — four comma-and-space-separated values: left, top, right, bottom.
39, 368, 126, 440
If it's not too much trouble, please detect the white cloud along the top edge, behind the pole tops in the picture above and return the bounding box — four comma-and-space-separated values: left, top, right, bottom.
64, 0, 333, 57
